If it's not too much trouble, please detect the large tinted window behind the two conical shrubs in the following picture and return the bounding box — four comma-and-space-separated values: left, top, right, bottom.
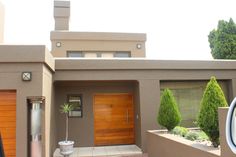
161, 81, 228, 127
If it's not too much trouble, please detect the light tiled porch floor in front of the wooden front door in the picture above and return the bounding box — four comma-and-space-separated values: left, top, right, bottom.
53, 145, 147, 157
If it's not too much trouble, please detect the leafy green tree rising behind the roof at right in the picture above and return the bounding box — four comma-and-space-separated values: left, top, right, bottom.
208, 18, 236, 59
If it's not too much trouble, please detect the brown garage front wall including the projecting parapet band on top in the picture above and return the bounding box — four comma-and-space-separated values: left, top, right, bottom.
0, 45, 52, 157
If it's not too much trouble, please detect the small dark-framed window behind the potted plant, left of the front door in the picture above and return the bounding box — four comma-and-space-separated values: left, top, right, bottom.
67, 94, 83, 118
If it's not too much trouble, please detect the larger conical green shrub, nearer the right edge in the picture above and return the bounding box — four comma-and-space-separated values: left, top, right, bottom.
197, 77, 228, 147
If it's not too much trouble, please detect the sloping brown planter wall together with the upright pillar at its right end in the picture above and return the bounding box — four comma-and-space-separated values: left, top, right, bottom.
147, 107, 236, 157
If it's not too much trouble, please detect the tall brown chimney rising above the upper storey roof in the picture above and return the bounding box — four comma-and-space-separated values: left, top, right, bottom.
54, 0, 70, 30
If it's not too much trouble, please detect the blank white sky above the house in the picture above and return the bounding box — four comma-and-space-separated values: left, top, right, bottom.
0, 0, 236, 60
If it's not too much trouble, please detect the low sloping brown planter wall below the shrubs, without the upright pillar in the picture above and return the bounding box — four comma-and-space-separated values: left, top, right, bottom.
147, 131, 220, 157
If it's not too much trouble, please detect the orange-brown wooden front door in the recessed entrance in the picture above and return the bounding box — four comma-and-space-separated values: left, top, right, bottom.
93, 94, 134, 146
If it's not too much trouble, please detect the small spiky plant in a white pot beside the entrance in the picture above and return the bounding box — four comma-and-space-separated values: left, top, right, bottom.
58, 103, 75, 157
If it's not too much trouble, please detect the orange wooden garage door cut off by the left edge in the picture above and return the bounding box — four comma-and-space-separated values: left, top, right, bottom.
0, 90, 16, 157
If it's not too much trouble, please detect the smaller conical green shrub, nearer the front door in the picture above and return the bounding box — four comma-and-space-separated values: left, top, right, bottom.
157, 89, 181, 131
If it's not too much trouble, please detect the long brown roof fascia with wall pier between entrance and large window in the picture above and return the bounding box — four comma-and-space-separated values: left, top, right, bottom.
54, 59, 236, 152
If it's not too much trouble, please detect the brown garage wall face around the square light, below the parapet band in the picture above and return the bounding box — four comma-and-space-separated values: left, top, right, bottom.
0, 63, 44, 157
